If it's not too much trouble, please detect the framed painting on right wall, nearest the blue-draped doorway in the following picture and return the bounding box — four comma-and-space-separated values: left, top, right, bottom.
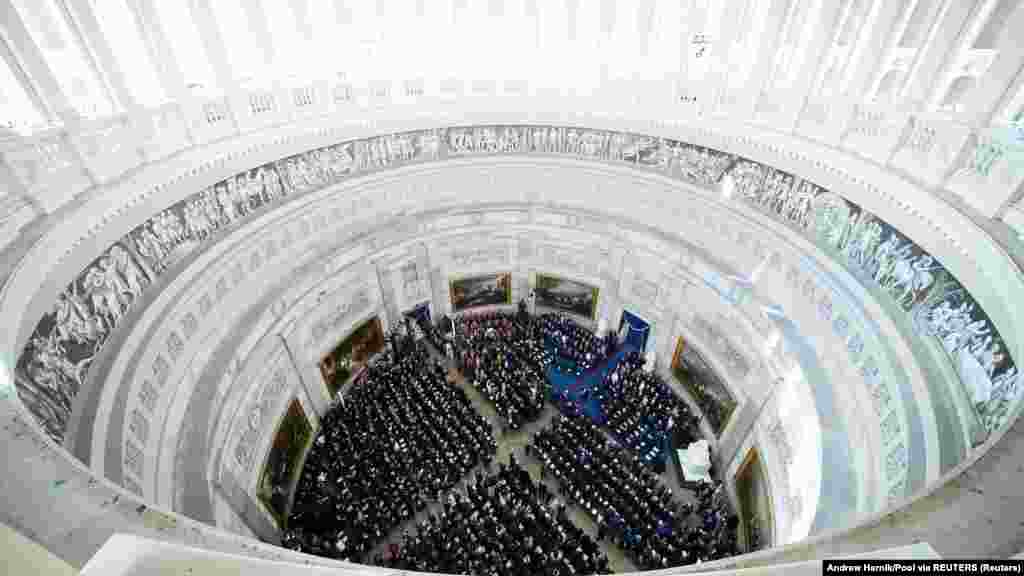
672, 336, 736, 437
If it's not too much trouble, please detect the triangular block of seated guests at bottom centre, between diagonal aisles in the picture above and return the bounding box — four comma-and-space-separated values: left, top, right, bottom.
375, 455, 611, 576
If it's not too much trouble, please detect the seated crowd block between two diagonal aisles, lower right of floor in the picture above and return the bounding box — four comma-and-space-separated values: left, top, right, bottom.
527, 415, 734, 570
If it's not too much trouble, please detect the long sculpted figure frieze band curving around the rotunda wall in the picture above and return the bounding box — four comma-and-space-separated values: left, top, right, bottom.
15, 125, 1020, 457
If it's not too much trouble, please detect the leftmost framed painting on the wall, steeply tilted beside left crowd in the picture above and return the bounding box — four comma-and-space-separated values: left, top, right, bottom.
256, 398, 313, 528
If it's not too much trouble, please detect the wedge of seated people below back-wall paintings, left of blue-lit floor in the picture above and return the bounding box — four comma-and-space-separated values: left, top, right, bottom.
459, 314, 549, 430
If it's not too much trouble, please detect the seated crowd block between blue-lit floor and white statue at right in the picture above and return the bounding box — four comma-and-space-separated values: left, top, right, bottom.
600, 352, 699, 472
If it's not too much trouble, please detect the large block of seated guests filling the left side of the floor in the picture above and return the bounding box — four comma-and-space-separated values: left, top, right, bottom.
282, 346, 497, 559
